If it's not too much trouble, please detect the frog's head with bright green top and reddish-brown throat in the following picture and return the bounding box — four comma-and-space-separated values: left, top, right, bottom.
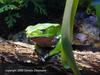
25, 23, 60, 47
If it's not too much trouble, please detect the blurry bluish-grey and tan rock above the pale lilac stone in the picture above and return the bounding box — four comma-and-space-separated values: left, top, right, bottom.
76, 15, 100, 40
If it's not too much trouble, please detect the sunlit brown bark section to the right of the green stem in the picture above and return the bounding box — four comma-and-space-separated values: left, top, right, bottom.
74, 51, 100, 72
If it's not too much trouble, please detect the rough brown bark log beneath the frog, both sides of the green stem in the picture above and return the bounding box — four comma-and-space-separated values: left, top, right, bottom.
0, 41, 100, 72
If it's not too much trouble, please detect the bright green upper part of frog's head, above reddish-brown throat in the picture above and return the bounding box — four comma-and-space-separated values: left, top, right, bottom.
25, 23, 60, 38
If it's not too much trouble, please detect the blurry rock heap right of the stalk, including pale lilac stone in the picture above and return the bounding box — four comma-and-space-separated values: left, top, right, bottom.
73, 15, 100, 45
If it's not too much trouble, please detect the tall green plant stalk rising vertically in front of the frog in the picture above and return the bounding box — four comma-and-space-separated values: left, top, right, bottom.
61, 0, 80, 75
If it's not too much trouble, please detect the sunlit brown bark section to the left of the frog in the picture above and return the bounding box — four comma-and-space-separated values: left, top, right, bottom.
0, 41, 38, 63
